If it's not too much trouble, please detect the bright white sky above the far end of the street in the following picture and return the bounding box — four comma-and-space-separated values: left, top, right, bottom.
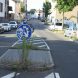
27, 0, 43, 10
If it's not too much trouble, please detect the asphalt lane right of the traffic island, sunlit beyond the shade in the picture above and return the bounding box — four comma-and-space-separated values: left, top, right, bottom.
28, 21, 78, 78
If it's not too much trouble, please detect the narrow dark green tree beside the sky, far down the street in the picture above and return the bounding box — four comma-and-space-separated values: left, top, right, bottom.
43, 0, 51, 22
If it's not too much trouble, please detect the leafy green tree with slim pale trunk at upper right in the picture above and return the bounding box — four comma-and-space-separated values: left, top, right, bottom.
56, 0, 78, 28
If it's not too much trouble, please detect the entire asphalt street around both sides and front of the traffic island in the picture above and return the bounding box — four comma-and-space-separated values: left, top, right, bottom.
0, 20, 78, 78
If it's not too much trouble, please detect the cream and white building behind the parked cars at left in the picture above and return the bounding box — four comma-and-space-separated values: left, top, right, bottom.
11, 0, 24, 20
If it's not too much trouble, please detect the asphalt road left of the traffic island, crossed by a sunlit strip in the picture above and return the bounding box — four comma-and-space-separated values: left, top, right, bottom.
0, 30, 17, 56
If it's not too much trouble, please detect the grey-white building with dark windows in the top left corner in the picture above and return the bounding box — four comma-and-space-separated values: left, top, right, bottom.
0, 0, 12, 22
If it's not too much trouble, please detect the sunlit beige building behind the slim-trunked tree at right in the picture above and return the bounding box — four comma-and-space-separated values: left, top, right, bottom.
56, 6, 78, 23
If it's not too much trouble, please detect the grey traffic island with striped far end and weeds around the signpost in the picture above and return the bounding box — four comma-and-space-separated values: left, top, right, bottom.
0, 37, 54, 70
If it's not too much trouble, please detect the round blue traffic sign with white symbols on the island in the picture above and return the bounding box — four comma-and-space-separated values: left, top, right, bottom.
16, 24, 32, 40
